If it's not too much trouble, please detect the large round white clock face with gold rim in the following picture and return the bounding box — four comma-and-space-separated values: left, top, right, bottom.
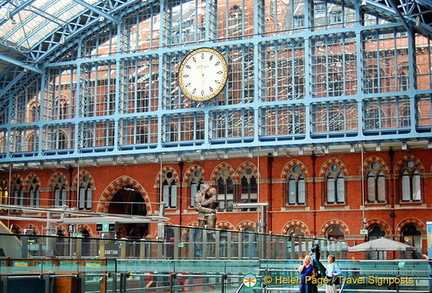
178, 48, 228, 101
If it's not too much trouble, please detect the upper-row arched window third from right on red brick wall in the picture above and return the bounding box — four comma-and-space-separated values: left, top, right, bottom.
326, 164, 345, 204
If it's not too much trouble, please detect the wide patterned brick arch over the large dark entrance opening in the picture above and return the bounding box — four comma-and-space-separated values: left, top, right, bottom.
96, 175, 152, 215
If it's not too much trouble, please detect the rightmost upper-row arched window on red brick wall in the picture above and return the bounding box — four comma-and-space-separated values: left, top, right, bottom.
400, 160, 422, 202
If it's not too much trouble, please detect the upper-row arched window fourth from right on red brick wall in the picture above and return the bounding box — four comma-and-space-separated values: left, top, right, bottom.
285, 165, 306, 206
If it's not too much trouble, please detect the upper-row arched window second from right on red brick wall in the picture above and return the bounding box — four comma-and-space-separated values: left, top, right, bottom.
366, 162, 386, 203
